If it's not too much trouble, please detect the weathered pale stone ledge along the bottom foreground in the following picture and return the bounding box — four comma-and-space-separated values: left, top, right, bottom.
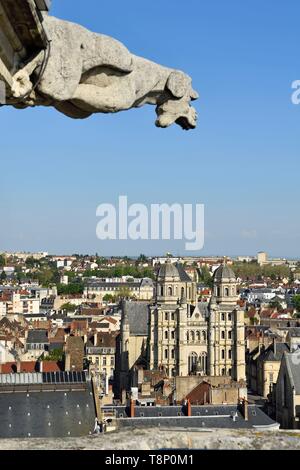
0, 429, 300, 450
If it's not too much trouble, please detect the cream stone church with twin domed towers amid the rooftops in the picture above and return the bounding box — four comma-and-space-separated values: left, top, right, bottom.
116, 259, 246, 390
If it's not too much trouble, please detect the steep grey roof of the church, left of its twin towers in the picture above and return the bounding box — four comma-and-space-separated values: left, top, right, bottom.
122, 301, 149, 336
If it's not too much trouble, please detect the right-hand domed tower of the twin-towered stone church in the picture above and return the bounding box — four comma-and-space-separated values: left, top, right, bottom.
208, 262, 246, 381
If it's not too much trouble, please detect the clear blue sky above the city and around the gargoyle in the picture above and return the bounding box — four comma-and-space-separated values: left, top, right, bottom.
0, 0, 300, 257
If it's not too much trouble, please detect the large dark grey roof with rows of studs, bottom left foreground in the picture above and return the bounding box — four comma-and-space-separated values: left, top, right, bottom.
0, 385, 96, 439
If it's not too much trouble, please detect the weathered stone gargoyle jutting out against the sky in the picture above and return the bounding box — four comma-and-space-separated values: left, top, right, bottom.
9, 15, 198, 130
